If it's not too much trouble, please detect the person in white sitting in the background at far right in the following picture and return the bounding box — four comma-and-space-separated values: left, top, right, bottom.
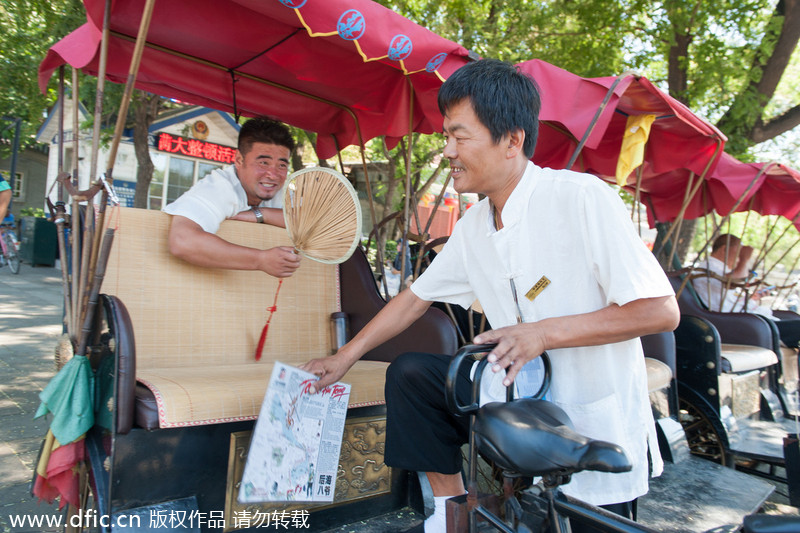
692, 233, 800, 348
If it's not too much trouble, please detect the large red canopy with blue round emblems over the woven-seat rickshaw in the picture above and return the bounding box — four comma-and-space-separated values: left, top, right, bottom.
39, 0, 469, 158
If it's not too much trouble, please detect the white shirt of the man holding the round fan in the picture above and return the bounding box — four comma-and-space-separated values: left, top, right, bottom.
164, 165, 283, 233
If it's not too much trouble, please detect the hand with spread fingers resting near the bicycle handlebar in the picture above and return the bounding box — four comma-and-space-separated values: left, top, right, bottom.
474, 322, 545, 387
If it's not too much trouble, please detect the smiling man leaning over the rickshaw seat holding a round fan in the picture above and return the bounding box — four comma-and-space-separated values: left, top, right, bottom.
164, 117, 300, 278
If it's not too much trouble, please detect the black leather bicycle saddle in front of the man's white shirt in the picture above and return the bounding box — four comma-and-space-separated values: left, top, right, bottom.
473, 398, 632, 476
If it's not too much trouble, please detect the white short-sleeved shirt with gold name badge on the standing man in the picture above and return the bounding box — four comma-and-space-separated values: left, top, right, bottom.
411, 163, 674, 505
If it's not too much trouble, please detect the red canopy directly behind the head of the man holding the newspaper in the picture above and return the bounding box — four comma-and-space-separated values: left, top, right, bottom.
519, 60, 744, 227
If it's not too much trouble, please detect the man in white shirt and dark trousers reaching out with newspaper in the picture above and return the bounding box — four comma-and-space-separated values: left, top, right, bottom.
305, 60, 679, 533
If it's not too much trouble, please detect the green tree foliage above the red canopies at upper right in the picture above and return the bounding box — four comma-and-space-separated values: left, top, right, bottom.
381, 0, 800, 162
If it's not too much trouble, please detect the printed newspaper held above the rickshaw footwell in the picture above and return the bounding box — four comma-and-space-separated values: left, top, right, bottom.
239, 362, 350, 503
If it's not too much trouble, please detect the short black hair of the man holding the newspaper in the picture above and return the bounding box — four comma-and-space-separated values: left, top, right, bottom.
439, 59, 541, 159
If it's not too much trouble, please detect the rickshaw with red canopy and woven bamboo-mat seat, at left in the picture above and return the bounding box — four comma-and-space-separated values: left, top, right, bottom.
37, 0, 470, 531
